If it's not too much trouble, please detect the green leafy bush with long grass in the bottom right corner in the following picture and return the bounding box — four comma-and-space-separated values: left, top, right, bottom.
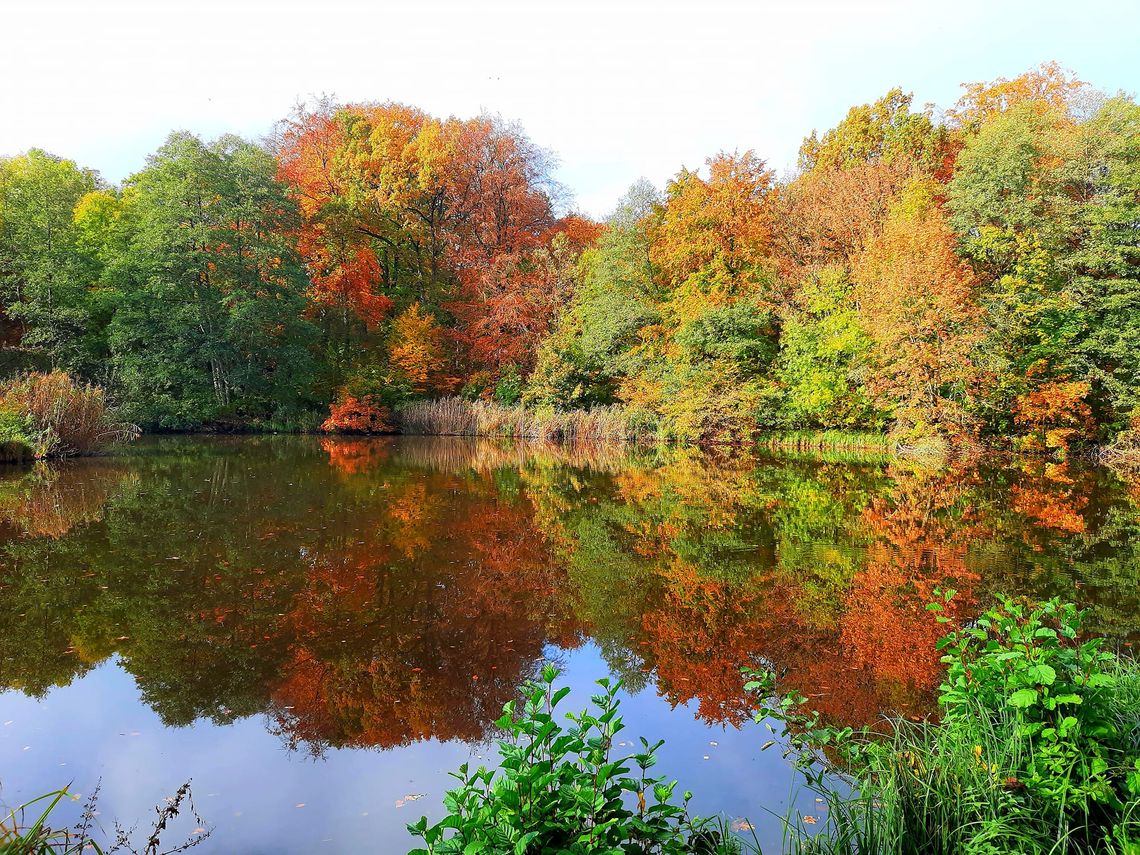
749, 592, 1140, 855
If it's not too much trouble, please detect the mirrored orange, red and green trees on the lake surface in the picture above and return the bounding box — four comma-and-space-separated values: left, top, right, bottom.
0, 438, 1140, 843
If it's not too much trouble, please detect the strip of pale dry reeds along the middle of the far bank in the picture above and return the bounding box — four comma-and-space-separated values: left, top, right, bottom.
396, 398, 656, 442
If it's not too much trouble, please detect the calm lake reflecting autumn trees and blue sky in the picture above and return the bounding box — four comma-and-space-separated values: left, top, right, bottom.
0, 437, 1140, 853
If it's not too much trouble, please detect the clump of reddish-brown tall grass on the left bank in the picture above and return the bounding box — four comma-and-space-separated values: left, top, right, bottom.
0, 371, 139, 458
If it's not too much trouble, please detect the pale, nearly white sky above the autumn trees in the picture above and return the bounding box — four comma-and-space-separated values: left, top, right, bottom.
0, 0, 1140, 217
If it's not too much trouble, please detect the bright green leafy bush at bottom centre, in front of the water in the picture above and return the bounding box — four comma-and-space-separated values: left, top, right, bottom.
408, 665, 739, 855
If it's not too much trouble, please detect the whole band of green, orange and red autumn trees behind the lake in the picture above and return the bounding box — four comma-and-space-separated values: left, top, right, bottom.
0, 64, 1140, 450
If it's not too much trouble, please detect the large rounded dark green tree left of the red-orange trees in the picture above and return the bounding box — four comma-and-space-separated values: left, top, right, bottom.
106, 133, 315, 429
